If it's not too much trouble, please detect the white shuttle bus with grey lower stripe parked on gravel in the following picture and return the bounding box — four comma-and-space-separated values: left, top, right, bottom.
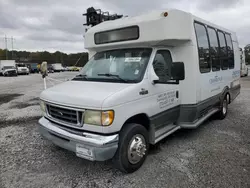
39, 10, 240, 173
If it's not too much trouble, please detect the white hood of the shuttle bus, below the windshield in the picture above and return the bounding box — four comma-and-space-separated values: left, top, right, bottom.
40, 81, 131, 109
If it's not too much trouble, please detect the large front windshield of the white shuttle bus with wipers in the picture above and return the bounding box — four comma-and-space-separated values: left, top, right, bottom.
74, 48, 152, 83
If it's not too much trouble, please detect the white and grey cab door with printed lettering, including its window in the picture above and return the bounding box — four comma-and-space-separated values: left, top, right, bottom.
147, 49, 180, 140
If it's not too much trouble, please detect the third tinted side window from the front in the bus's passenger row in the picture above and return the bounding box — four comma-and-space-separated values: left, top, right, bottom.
218, 31, 228, 70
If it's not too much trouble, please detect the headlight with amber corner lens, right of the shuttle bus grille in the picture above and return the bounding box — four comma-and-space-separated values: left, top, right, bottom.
84, 110, 114, 126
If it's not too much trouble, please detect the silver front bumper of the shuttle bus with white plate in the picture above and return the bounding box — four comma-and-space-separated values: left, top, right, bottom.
39, 117, 119, 161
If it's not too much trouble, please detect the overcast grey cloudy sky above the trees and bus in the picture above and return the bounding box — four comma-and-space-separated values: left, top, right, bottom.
0, 0, 250, 53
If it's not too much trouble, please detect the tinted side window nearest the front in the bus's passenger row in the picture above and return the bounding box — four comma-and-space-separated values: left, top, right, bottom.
195, 23, 211, 73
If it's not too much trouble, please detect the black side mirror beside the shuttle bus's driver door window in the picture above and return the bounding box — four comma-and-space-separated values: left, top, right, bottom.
171, 62, 185, 81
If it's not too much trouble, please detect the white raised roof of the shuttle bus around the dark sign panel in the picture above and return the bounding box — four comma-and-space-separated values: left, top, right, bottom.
85, 9, 236, 49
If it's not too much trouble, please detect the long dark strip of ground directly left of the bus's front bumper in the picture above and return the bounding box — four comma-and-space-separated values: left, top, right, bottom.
0, 116, 41, 129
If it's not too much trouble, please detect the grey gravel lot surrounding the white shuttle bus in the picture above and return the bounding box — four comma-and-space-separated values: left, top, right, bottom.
0, 72, 250, 188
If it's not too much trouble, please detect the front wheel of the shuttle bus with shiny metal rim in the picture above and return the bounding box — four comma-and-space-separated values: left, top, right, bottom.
113, 123, 149, 173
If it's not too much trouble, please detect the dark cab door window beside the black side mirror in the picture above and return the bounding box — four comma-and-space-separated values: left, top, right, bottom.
153, 50, 172, 83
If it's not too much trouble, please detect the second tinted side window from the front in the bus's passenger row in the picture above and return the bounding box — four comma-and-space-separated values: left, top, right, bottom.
207, 28, 220, 71
